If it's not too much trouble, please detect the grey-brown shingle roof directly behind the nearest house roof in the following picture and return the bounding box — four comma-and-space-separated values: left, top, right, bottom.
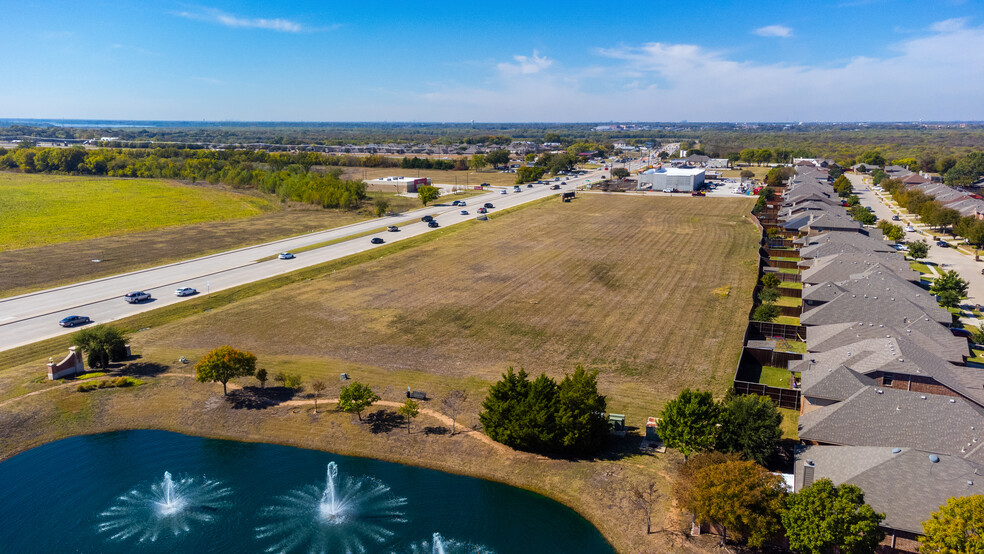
799, 384, 984, 463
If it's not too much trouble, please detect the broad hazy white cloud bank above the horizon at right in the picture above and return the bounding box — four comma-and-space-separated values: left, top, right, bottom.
398, 21, 984, 121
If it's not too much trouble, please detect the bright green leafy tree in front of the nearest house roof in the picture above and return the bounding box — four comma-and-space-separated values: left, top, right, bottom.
782, 478, 885, 554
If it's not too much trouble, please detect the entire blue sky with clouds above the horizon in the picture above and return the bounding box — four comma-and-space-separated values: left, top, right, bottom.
0, 0, 984, 122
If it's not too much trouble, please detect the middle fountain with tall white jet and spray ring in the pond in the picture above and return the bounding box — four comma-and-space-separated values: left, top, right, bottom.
256, 462, 407, 552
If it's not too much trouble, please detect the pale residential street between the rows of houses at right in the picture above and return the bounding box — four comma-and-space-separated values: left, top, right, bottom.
845, 173, 984, 305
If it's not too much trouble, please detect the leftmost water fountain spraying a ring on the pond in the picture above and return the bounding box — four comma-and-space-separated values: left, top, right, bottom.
96, 471, 232, 542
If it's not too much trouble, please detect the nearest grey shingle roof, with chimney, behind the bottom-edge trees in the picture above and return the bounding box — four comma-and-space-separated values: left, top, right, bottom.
793, 446, 984, 534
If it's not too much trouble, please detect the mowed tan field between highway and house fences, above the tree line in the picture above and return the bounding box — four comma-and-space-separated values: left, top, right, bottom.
137, 194, 758, 410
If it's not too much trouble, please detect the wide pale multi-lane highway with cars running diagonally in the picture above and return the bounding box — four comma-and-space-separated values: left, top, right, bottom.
0, 170, 608, 351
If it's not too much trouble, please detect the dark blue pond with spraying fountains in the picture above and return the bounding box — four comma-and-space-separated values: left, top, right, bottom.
0, 431, 613, 554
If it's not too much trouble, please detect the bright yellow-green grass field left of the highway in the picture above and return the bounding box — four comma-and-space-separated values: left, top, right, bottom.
0, 173, 275, 251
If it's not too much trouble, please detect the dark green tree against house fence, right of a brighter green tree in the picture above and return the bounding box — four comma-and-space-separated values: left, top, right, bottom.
718, 394, 782, 465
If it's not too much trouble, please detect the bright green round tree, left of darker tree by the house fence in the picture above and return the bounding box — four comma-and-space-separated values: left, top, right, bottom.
659, 388, 721, 456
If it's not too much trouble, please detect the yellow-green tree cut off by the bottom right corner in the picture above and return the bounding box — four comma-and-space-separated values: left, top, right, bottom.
919, 494, 984, 554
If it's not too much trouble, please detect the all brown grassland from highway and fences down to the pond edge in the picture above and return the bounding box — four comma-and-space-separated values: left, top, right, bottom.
0, 195, 758, 552
